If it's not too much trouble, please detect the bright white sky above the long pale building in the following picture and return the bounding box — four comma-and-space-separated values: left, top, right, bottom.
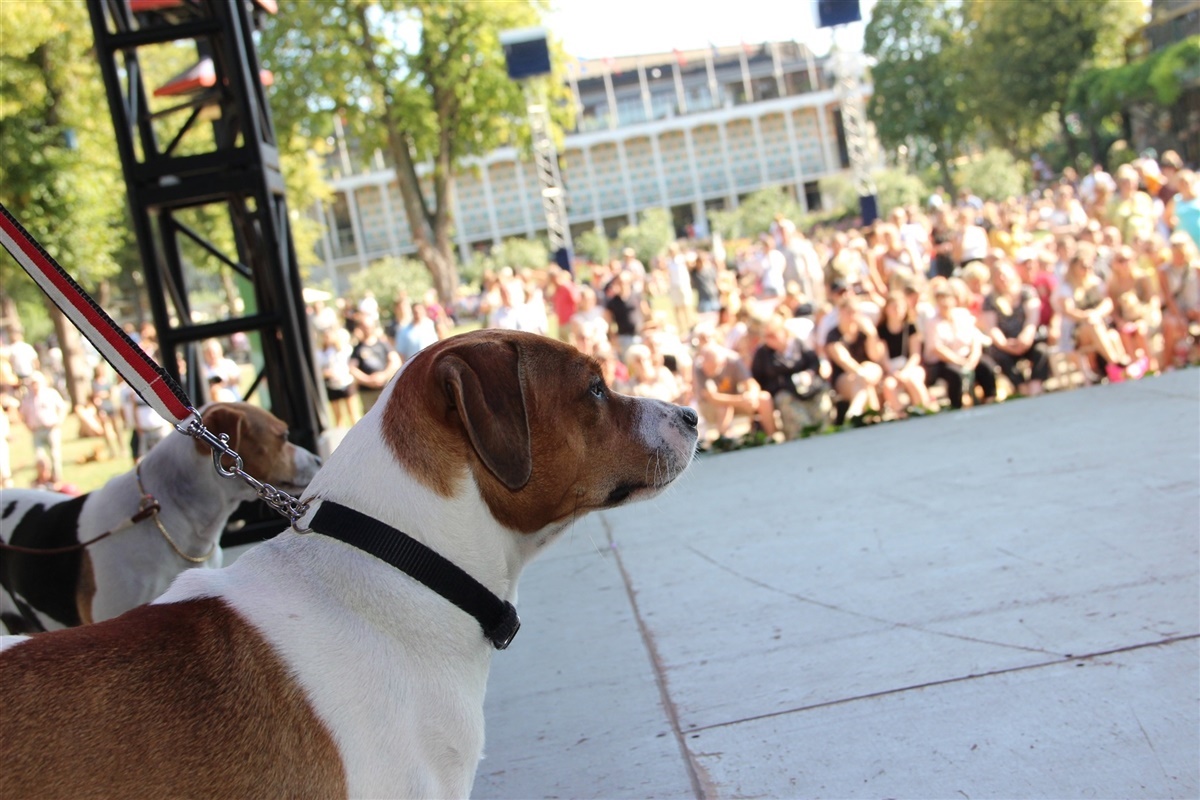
545, 0, 876, 59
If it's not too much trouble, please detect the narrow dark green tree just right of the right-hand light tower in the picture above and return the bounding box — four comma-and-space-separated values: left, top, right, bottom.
863, 0, 974, 185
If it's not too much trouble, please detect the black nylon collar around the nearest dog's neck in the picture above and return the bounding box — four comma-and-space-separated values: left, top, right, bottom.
308, 500, 521, 650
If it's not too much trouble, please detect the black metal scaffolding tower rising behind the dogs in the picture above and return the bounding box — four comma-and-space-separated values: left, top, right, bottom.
88, 0, 324, 544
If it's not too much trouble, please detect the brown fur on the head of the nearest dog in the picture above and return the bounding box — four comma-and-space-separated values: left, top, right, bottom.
383, 330, 672, 533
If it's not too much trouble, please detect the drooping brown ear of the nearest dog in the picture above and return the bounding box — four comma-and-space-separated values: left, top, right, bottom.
436, 342, 533, 491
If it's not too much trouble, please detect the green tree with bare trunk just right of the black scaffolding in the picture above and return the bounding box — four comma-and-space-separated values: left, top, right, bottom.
262, 0, 571, 302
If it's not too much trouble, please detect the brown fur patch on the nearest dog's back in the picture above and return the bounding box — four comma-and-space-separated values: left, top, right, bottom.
0, 599, 347, 798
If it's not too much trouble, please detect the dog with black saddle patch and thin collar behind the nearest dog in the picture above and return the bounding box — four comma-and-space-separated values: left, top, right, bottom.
0, 403, 320, 633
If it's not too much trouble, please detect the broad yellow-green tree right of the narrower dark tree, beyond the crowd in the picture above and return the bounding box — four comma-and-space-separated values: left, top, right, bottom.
965, 0, 1145, 161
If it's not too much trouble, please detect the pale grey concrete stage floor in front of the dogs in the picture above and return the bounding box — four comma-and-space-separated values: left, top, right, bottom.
474, 369, 1200, 799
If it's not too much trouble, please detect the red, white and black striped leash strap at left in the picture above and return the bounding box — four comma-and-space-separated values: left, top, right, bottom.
0, 204, 199, 429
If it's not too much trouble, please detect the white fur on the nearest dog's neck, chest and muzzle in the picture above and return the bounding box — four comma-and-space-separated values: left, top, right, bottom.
160, 380, 695, 798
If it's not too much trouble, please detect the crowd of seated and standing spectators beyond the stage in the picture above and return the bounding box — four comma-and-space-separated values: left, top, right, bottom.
0, 152, 1200, 486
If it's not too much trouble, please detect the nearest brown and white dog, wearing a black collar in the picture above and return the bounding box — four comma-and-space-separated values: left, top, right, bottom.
0, 331, 697, 798
